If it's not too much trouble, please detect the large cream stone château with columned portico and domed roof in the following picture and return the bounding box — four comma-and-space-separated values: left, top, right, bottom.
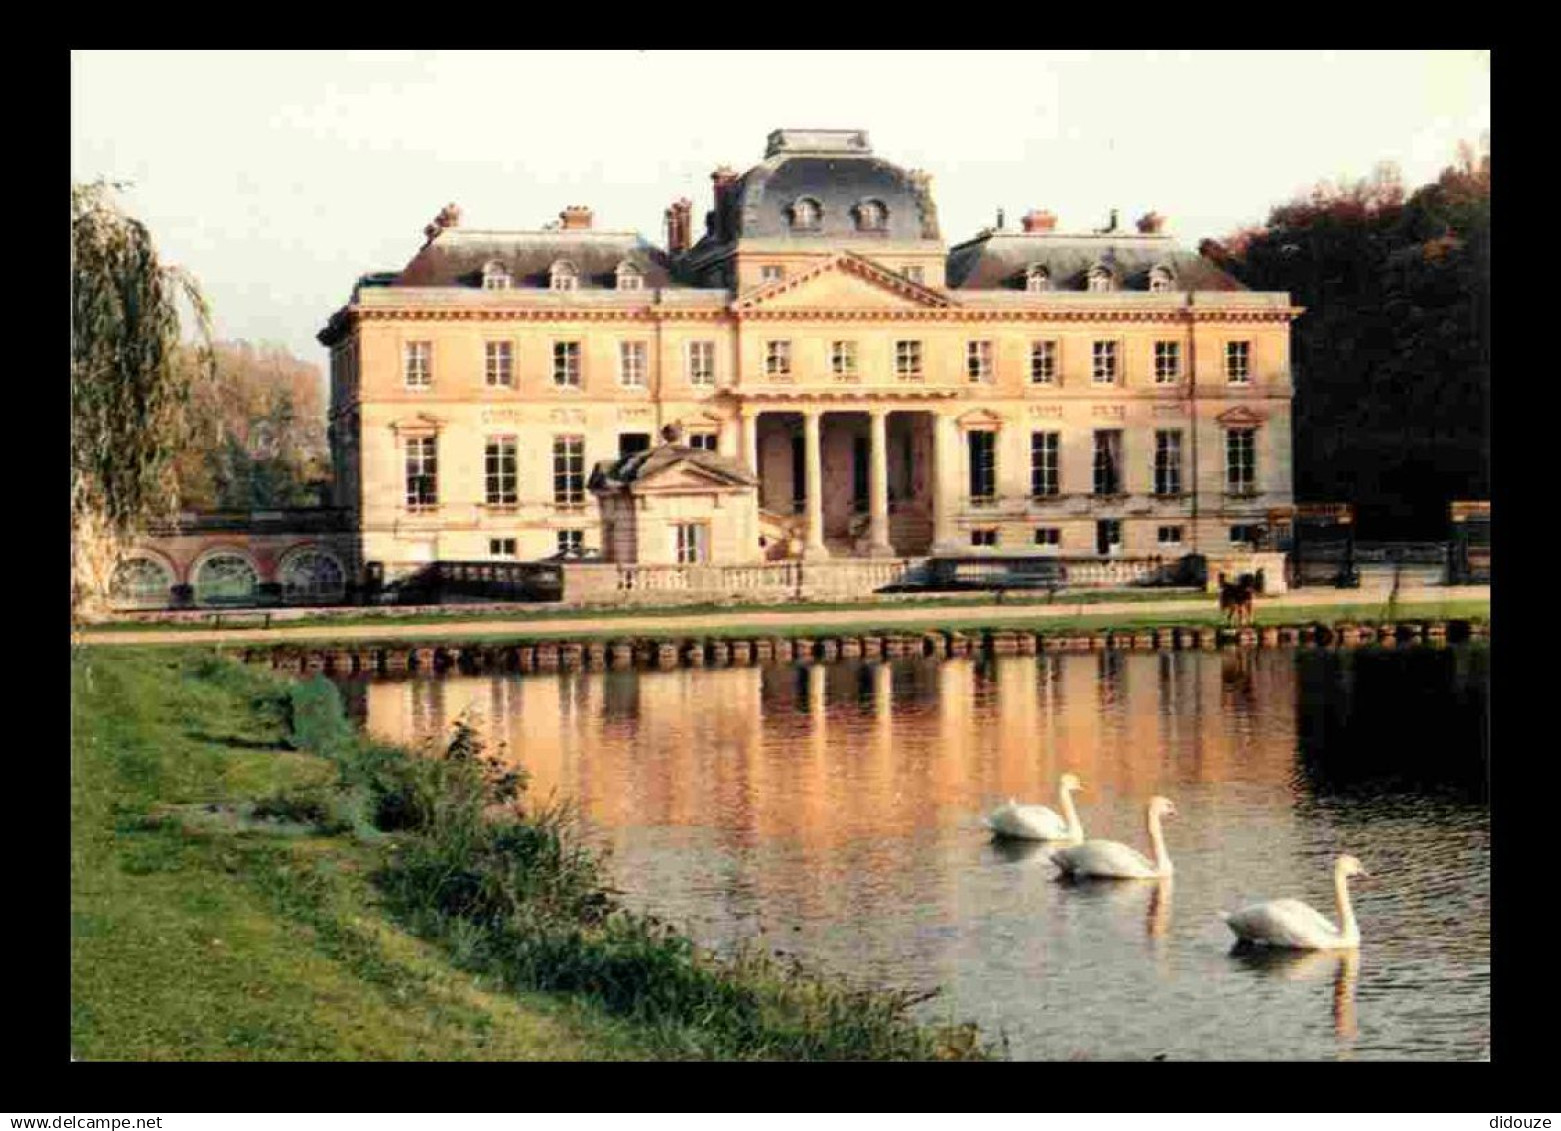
318, 129, 1300, 589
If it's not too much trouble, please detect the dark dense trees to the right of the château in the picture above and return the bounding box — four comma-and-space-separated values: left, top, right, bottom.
1200, 147, 1491, 538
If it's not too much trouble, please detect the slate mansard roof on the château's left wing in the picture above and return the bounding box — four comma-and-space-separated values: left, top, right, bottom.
390, 228, 671, 290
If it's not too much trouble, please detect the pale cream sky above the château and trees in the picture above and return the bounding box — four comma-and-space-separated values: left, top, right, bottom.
70, 51, 1491, 367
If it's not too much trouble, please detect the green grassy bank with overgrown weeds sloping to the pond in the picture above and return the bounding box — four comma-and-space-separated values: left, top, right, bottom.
72, 647, 982, 1059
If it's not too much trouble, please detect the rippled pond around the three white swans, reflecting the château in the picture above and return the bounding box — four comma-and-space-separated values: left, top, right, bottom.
343, 644, 1491, 1059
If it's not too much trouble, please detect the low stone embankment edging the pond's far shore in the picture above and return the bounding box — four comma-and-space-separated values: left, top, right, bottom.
244, 621, 1489, 675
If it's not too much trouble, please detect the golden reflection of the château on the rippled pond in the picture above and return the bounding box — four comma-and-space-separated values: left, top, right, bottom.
367, 652, 1296, 850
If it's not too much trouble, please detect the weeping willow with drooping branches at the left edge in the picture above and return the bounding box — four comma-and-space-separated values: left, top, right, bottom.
70, 181, 211, 616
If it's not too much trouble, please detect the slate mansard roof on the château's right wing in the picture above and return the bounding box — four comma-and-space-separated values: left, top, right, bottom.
948, 231, 1247, 292
